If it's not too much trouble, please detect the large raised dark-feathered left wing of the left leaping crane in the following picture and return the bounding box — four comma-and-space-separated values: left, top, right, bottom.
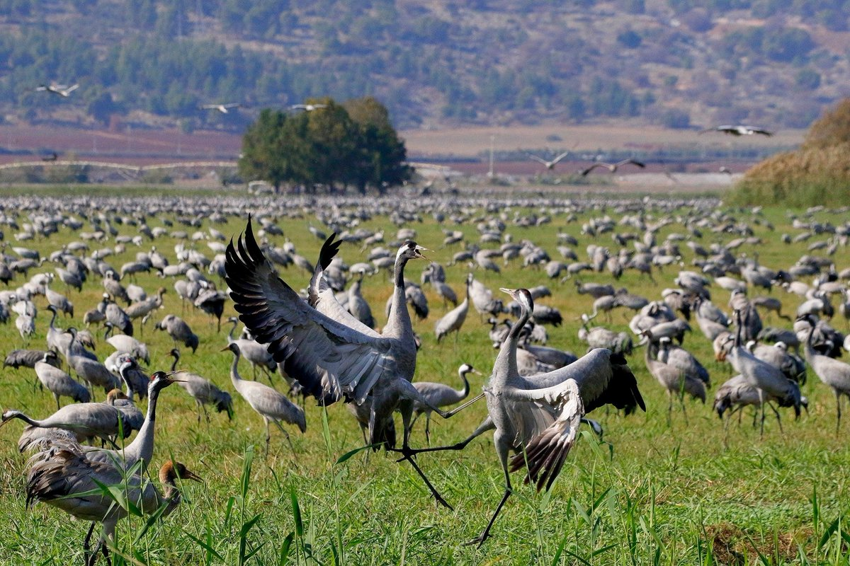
225, 219, 395, 403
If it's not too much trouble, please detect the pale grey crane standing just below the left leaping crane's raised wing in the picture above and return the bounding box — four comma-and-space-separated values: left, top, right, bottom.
222, 342, 307, 456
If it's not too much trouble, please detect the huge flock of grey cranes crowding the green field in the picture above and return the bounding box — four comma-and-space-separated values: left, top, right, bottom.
0, 197, 850, 564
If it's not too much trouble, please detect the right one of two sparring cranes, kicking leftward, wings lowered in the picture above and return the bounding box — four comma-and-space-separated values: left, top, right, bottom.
408, 289, 645, 546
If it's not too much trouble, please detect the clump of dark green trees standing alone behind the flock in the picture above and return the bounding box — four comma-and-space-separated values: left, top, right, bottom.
239, 97, 412, 193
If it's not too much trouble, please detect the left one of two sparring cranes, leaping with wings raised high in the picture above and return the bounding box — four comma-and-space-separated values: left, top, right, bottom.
225, 224, 450, 506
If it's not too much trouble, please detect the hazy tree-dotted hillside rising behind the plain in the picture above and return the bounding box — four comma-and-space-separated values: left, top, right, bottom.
0, 0, 850, 131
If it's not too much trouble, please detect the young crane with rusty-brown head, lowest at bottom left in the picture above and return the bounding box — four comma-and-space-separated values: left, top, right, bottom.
26, 454, 200, 566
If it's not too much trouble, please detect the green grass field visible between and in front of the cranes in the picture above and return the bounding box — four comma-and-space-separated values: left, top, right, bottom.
0, 189, 850, 565
